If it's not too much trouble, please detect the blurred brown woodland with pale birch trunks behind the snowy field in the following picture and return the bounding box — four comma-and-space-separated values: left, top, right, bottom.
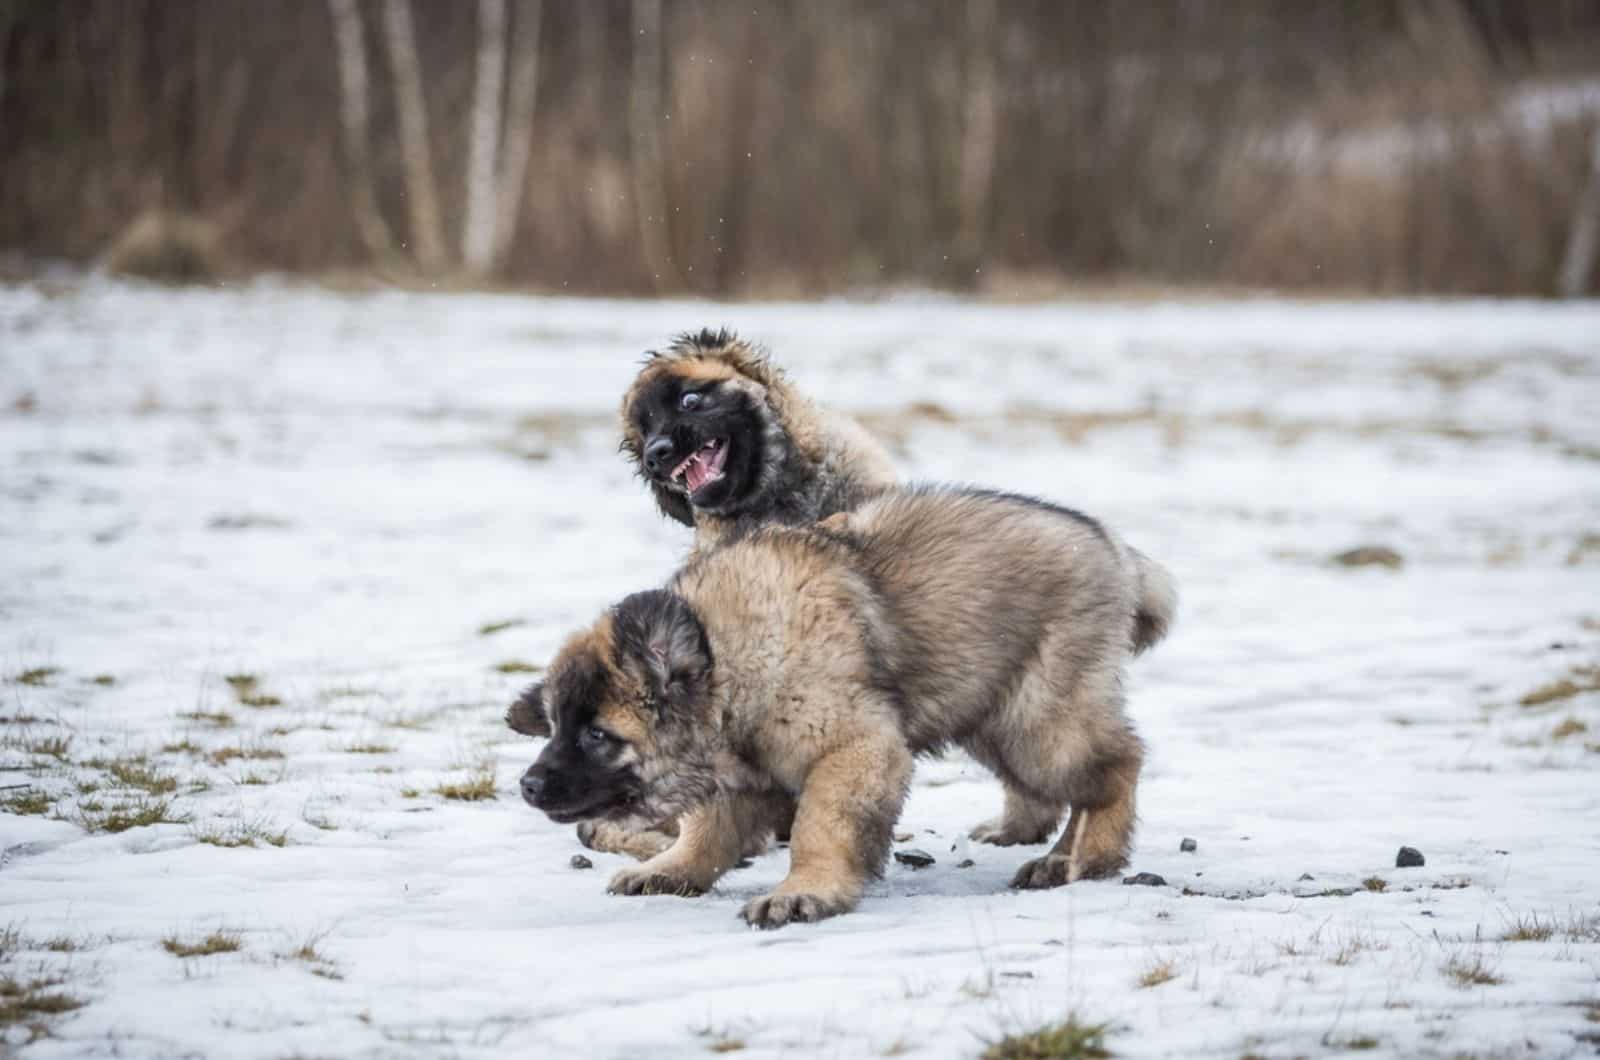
0, 0, 1600, 298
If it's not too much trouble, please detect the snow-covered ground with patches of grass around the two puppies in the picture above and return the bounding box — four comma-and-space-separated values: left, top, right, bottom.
0, 282, 1600, 1058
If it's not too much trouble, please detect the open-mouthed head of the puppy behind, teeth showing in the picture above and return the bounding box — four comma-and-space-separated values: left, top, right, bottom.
622, 330, 784, 527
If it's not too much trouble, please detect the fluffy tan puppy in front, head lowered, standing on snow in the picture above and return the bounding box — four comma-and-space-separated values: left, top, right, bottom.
522, 488, 1174, 927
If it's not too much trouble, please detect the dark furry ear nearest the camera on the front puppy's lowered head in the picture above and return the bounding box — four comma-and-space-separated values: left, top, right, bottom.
613, 589, 712, 709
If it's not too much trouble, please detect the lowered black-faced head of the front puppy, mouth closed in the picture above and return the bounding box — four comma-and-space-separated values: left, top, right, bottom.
522, 591, 715, 823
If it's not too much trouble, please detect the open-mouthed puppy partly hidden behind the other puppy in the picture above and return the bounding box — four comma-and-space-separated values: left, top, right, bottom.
506, 328, 894, 858
